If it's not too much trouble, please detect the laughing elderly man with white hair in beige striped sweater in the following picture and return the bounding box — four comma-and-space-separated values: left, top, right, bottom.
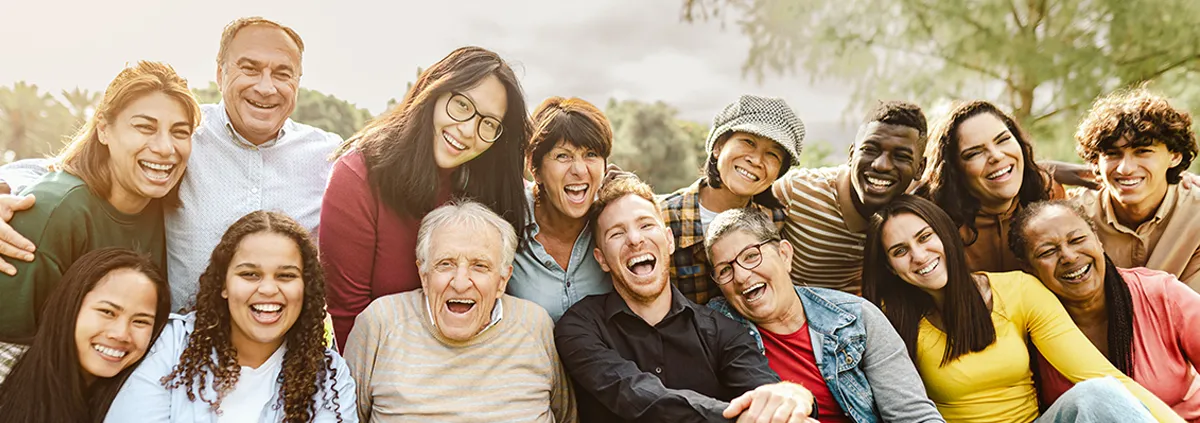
344, 201, 577, 422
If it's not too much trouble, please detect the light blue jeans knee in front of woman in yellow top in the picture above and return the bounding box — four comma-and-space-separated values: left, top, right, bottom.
1033, 377, 1154, 423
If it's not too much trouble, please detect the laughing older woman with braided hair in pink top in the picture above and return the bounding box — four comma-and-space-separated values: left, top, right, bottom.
1008, 201, 1200, 422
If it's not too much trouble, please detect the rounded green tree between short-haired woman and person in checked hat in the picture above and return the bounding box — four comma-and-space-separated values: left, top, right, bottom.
605, 100, 707, 193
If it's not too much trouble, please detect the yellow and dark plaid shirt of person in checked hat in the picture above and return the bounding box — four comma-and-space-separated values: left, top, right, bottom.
659, 178, 787, 304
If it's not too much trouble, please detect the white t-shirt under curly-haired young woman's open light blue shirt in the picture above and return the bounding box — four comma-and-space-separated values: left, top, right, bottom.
217, 344, 288, 423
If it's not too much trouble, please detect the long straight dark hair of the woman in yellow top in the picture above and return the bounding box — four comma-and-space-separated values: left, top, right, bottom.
863, 195, 996, 365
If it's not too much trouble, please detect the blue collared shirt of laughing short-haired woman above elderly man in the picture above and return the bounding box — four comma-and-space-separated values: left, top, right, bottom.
508, 190, 612, 322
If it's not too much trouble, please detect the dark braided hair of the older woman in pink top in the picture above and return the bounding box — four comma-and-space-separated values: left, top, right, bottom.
1008, 199, 1134, 377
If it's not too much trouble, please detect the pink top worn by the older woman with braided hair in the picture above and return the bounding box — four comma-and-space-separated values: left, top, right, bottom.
1038, 267, 1200, 423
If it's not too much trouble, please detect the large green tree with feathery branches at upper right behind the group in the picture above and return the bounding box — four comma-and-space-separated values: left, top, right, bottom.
683, 0, 1200, 160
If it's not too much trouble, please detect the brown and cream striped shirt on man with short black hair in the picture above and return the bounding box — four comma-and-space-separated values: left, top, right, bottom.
774, 165, 866, 294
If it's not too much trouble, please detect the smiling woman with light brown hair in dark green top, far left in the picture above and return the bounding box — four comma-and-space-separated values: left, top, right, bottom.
0, 61, 200, 339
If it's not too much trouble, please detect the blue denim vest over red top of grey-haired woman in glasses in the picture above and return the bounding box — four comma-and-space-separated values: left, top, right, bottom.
708, 286, 888, 423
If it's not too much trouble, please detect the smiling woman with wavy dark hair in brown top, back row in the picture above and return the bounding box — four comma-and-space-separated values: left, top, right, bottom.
916, 101, 1063, 272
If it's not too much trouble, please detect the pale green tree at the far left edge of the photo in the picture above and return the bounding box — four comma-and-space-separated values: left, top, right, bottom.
0, 82, 78, 161
